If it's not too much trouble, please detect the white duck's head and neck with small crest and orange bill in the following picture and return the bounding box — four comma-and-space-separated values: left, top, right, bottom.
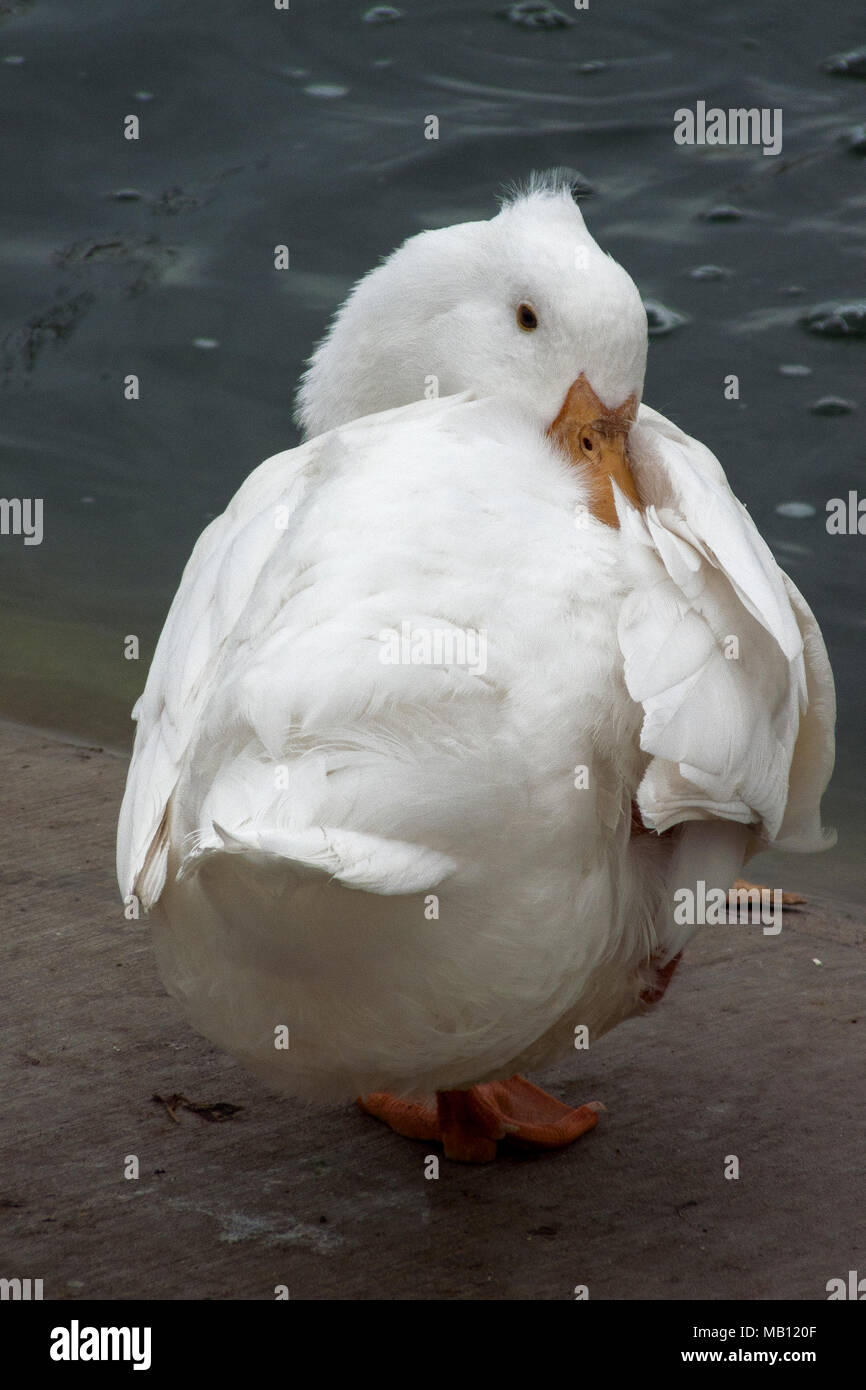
296, 174, 646, 524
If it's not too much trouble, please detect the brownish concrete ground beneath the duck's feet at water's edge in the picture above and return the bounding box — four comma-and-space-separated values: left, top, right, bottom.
0, 724, 866, 1300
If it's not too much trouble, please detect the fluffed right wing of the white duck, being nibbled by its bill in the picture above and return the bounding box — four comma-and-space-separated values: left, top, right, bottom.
617, 406, 835, 851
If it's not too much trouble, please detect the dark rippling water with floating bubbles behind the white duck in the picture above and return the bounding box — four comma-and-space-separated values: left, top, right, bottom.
0, 0, 866, 887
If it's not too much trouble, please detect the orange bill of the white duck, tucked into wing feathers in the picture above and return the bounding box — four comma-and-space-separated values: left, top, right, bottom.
548, 371, 641, 527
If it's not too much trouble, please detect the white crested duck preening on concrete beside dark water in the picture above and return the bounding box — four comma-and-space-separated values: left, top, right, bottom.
118, 178, 834, 1159
